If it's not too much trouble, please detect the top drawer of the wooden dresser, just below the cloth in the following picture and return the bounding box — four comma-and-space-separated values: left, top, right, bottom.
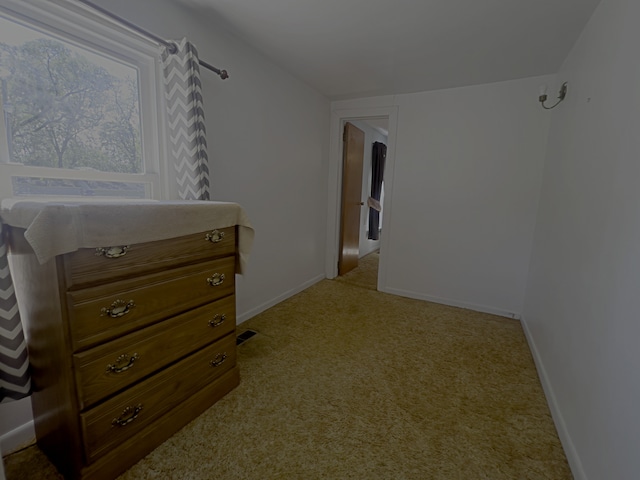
64, 227, 236, 290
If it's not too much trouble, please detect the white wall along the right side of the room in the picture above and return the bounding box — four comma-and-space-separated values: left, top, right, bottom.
524, 0, 640, 480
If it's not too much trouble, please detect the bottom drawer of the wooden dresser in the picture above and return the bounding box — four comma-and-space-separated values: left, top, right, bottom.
80, 335, 236, 463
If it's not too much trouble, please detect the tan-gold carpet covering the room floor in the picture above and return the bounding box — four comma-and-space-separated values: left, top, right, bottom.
6, 254, 572, 480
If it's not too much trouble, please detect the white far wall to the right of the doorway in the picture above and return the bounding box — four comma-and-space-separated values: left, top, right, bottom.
330, 76, 554, 317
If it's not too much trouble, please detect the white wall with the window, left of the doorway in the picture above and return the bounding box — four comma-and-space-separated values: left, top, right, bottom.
0, 0, 330, 453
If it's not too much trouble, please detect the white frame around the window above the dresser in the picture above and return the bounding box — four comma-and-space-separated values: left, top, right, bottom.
0, 0, 170, 199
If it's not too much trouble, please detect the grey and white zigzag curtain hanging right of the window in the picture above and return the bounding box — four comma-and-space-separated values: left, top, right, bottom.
162, 38, 209, 200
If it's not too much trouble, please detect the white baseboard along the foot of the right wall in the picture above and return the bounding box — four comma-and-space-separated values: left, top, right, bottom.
520, 319, 587, 480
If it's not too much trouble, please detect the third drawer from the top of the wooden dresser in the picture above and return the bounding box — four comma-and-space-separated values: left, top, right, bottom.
73, 295, 236, 410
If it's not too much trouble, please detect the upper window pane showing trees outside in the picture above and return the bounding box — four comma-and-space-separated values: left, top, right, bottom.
0, 17, 144, 173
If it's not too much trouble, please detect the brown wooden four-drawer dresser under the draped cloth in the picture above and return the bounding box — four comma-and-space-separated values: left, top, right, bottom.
9, 219, 245, 479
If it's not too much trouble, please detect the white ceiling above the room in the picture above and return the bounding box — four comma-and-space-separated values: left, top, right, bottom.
170, 0, 600, 100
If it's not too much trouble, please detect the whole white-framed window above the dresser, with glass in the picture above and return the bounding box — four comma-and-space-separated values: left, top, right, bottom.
0, 0, 168, 198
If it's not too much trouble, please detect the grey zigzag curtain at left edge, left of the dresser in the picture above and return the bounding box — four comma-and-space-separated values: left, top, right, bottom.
0, 222, 31, 403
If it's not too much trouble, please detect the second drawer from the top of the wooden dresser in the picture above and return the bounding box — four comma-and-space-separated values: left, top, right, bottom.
67, 257, 235, 351
